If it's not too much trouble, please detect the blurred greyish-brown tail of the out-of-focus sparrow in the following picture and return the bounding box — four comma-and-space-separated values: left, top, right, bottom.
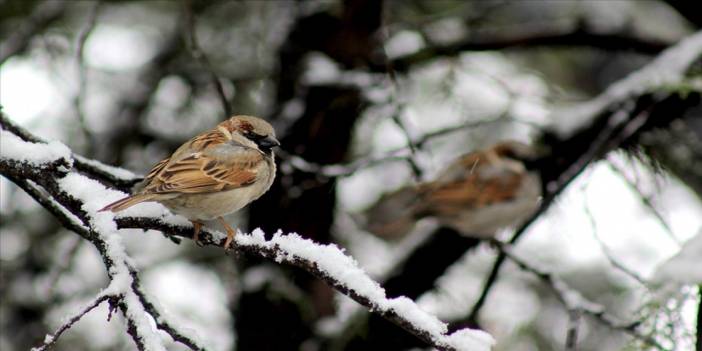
366, 186, 421, 240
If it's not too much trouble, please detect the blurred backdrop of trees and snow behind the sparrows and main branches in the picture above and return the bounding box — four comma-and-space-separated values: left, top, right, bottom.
0, 0, 702, 351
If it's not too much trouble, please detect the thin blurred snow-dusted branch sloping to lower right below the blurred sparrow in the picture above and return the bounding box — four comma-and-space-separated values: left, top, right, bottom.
491, 240, 667, 351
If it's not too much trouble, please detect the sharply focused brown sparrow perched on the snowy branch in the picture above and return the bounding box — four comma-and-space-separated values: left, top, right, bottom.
101, 116, 280, 249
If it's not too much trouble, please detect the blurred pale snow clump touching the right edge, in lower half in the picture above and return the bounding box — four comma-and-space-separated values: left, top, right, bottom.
652, 229, 702, 284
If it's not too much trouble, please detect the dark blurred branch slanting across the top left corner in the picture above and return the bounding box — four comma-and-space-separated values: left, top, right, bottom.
0, 0, 69, 65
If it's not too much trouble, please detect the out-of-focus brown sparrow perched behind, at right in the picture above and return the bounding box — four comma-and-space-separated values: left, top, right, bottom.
366, 141, 542, 239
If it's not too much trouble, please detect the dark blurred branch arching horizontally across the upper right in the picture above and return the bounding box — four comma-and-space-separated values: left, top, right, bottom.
384, 21, 675, 72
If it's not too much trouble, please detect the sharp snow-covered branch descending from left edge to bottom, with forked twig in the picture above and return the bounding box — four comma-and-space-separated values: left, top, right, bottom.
0, 116, 205, 350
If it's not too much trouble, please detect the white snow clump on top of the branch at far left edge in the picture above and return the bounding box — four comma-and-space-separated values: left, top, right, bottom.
0, 130, 73, 166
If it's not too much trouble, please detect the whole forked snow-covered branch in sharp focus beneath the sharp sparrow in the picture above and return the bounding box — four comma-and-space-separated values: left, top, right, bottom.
0, 118, 494, 350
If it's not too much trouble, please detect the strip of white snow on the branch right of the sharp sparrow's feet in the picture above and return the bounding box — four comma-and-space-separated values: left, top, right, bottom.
234, 229, 495, 350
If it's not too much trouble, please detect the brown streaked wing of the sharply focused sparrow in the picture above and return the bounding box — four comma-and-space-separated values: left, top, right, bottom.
143, 133, 266, 194
